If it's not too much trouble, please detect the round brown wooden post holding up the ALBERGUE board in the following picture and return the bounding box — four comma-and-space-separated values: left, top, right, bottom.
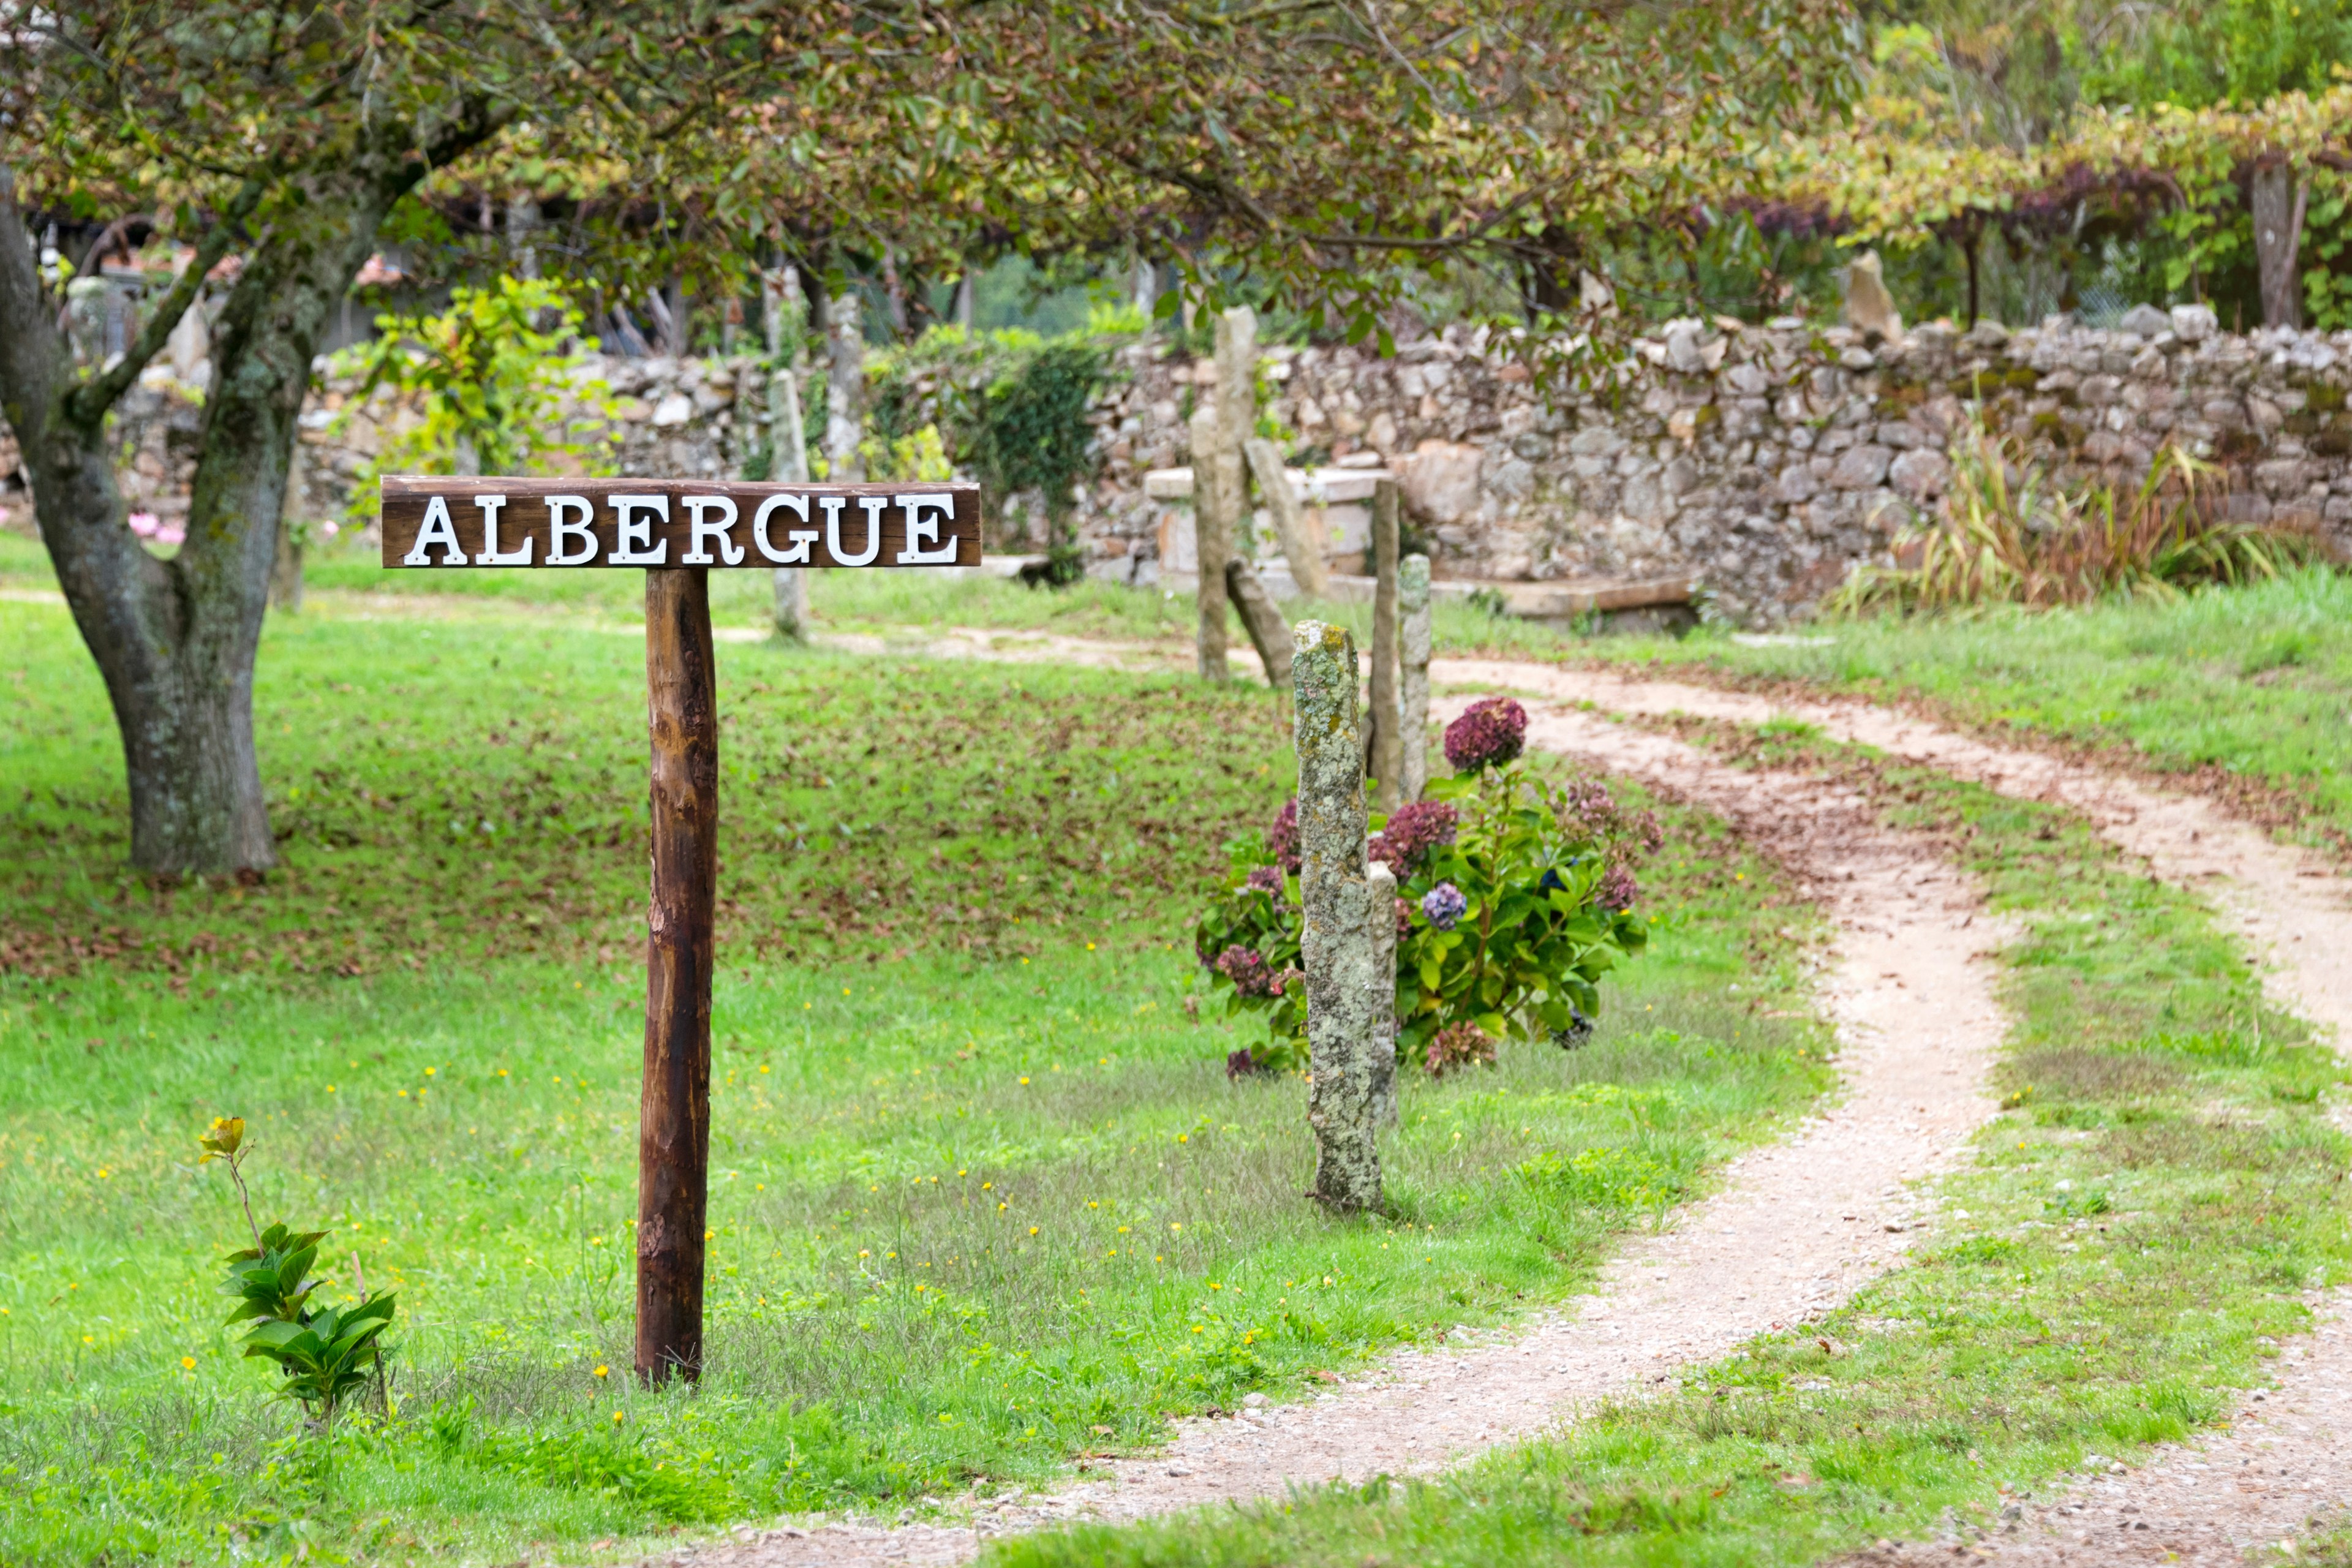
638, 567, 720, 1382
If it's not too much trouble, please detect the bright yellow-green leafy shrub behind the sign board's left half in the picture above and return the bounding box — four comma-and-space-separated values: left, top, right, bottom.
344, 277, 619, 522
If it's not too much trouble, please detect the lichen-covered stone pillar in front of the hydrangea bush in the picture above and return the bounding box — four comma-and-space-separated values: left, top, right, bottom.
1291, 620, 1395, 1213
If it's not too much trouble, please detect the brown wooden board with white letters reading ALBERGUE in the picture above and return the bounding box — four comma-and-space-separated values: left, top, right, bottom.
381, 475, 981, 581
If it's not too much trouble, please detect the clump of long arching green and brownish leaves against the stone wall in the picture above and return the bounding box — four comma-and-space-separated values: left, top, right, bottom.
1823, 416, 2319, 616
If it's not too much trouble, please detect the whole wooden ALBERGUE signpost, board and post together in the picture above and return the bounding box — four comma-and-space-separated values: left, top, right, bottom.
383, 475, 981, 1382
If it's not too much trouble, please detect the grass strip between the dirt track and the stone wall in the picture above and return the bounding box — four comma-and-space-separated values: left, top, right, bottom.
32, 533, 2352, 846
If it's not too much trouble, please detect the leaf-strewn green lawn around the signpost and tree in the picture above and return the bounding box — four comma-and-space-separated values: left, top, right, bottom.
0, 582, 1828, 1568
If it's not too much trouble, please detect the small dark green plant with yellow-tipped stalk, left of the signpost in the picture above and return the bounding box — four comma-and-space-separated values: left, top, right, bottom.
198, 1117, 393, 1427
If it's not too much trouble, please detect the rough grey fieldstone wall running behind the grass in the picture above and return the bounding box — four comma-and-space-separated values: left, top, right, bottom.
0, 306, 2352, 625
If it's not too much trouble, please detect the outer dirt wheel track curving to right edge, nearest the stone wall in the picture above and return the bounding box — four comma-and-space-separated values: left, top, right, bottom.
1430, 658, 2352, 1046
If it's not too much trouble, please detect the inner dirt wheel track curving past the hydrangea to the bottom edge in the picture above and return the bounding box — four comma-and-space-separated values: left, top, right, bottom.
673, 712, 2004, 1568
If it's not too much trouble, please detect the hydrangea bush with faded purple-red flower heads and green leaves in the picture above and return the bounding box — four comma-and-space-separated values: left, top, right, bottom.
1193, 698, 1660, 1072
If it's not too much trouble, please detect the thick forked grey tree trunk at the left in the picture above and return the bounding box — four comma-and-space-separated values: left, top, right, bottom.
0, 106, 499, 877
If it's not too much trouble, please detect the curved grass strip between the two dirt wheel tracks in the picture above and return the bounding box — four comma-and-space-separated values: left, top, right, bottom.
1006, 724, 2352, 1568
